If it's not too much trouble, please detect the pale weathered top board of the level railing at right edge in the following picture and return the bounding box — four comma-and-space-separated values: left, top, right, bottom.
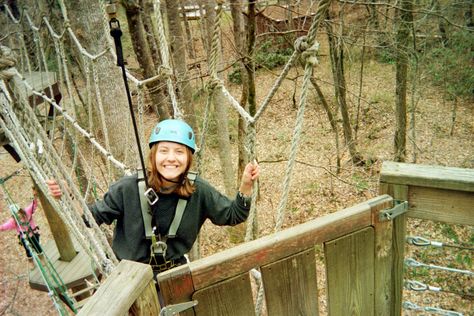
380, 161, 474, 192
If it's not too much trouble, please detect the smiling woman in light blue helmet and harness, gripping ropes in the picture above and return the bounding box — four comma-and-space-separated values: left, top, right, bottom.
47, 120, 259, 274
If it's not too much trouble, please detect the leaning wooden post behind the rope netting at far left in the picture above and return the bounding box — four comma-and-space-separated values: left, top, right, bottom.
31, 177, 77, 262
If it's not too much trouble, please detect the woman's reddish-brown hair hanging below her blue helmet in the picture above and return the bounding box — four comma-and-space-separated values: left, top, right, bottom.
147, 143, 196, 198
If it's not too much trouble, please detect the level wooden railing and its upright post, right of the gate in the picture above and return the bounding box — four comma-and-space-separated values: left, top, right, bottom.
379, 162, 474, 315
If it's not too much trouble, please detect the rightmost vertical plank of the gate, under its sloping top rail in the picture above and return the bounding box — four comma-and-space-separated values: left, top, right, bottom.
325, 227, 374, 316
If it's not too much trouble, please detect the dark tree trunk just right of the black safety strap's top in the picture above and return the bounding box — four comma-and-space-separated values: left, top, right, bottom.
124, 1, 170, 120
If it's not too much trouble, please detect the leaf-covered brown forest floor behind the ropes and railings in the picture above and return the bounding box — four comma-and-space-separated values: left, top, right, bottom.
0, 32, 474, 316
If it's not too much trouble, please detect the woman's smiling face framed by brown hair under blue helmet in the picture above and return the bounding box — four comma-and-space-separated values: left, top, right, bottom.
155, 142, 189, 181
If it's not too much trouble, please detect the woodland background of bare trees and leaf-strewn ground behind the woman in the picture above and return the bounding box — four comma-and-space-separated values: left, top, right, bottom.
0, 0, 474, 315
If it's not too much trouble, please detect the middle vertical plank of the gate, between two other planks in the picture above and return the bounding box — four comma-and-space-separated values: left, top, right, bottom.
261, 247, 319, 315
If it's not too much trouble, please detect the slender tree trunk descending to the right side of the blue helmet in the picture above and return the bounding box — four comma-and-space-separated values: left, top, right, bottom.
166, 1, 197, 131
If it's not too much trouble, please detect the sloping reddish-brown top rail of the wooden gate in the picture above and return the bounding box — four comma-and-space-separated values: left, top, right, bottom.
189, 195, 391, 290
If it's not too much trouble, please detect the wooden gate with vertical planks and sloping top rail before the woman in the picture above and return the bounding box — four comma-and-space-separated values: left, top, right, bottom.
158, 195, 392, 316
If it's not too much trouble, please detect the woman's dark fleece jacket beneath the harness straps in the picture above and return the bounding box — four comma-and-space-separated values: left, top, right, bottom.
90, 174, 250, 262
